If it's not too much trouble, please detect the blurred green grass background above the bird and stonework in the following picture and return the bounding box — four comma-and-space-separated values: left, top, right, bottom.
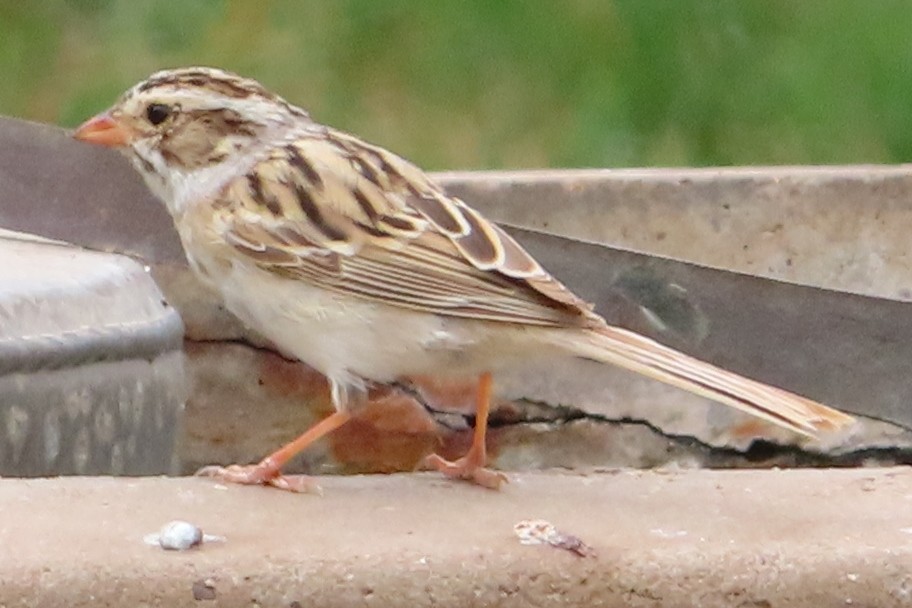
0, 0, 912, 169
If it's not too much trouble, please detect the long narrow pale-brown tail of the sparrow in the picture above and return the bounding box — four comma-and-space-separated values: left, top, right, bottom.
555, 326, 855, 437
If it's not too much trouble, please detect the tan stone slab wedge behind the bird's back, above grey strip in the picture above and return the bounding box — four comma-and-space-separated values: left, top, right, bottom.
435, 165, 912, 300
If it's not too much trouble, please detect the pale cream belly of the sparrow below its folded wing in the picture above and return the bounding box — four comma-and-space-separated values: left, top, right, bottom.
208, 262, 548, 382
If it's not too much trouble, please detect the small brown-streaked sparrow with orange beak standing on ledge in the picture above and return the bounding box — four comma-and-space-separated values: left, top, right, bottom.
73, 67, 853, 491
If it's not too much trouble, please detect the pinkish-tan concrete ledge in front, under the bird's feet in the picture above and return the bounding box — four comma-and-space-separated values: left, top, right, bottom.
0, 468, 912, 608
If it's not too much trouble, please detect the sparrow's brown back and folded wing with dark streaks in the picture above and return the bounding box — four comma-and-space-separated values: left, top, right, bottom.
218, 130, 600, 326
